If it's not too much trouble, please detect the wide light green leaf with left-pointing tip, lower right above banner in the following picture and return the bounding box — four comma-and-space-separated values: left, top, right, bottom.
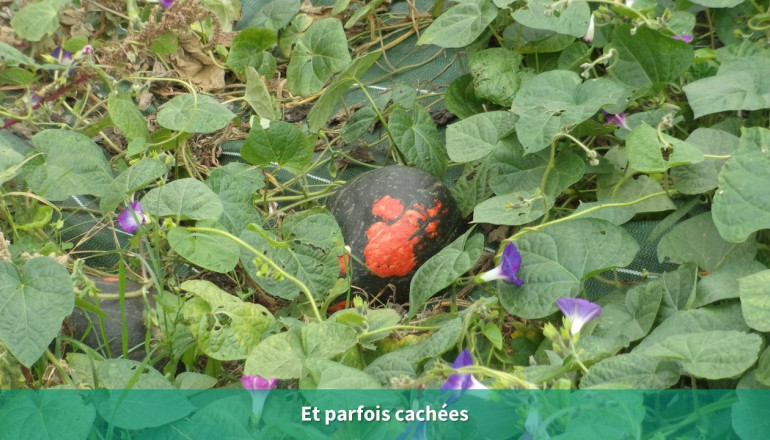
644, 330, 762, 379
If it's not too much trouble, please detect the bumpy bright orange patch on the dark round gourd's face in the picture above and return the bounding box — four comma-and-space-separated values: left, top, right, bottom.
364, 196, 441, 278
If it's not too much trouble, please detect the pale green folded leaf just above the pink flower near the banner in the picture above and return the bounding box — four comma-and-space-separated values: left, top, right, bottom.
244, 321, 357, 379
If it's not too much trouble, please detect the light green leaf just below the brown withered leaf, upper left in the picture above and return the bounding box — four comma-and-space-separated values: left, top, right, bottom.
157, 94, 235, 133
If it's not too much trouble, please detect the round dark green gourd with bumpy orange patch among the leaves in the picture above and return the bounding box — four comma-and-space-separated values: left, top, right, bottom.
329, 165, 461, 302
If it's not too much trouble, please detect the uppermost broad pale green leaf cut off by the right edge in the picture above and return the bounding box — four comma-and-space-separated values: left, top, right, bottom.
682, 55, 770, 118
